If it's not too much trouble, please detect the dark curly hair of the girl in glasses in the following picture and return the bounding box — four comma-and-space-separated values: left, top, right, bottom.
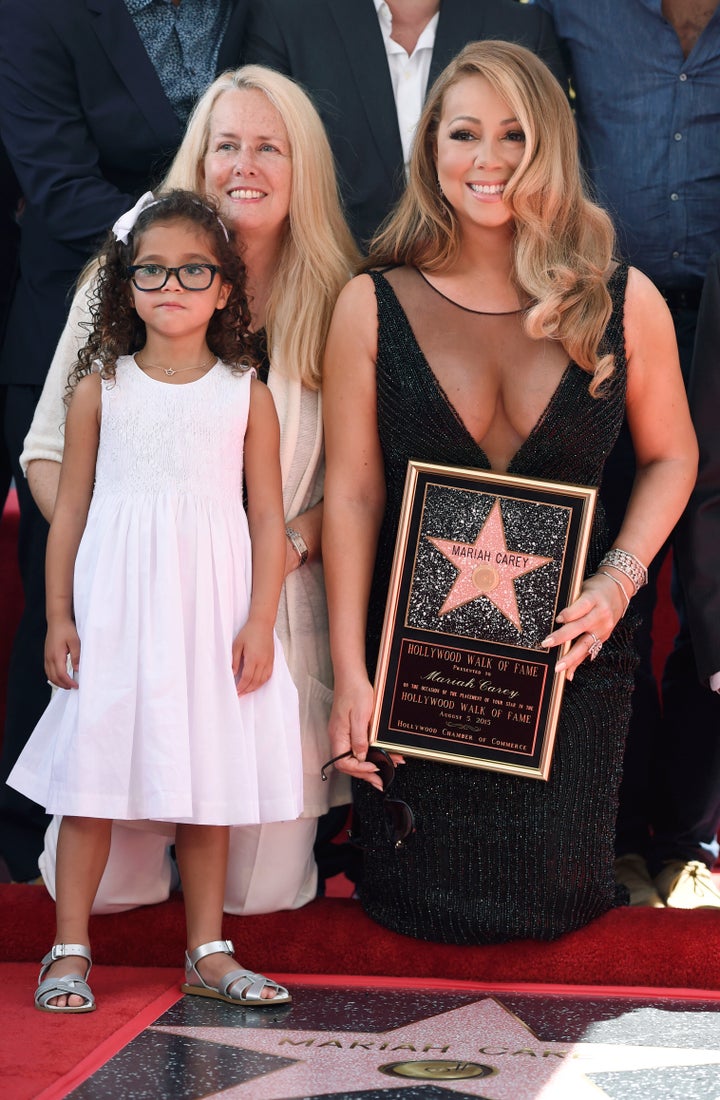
67, 189, 254, 399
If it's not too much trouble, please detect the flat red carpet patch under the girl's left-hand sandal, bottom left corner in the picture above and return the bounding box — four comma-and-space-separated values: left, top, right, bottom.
0, 963, 181, 1100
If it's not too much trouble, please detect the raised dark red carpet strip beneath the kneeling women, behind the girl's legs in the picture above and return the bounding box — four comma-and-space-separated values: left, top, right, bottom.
0, 886, 720, 990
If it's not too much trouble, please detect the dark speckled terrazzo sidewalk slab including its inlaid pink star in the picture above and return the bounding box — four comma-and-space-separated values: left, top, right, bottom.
66, 978, 720, 1100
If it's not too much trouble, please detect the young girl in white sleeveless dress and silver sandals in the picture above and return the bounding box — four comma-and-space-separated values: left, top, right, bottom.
10, 191, 302, 1012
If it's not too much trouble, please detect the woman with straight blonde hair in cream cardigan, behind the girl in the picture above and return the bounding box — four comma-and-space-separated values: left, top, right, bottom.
22, 66, 357, 913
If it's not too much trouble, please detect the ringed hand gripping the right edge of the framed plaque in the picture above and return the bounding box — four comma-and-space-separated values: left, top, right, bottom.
541, 573, 625, 680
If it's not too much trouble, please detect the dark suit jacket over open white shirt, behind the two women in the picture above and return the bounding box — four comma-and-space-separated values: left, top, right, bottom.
243, 0, 567, 244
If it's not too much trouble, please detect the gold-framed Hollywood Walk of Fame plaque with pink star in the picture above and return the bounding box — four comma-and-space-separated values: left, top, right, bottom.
370, 462, 597, 779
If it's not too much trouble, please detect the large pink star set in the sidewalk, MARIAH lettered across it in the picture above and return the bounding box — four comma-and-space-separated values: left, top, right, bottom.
158, 998, 720, 1100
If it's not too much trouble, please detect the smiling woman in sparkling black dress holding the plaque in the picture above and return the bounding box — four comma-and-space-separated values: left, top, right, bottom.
323, 42, 697, 943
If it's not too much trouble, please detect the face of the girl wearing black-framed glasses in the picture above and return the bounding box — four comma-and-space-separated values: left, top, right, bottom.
130, 220, 231, 341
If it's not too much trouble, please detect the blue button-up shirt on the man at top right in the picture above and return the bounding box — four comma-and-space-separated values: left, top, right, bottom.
535, 0, 720, 288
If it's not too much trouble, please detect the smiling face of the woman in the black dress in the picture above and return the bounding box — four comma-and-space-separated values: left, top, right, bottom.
436, 74, 525, 236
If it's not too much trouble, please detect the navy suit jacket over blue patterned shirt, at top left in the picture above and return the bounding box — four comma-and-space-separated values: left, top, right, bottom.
0, 0, 247, 385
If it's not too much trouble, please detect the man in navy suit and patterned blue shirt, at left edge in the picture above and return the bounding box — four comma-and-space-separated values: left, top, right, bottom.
0, 0, 246, 880
